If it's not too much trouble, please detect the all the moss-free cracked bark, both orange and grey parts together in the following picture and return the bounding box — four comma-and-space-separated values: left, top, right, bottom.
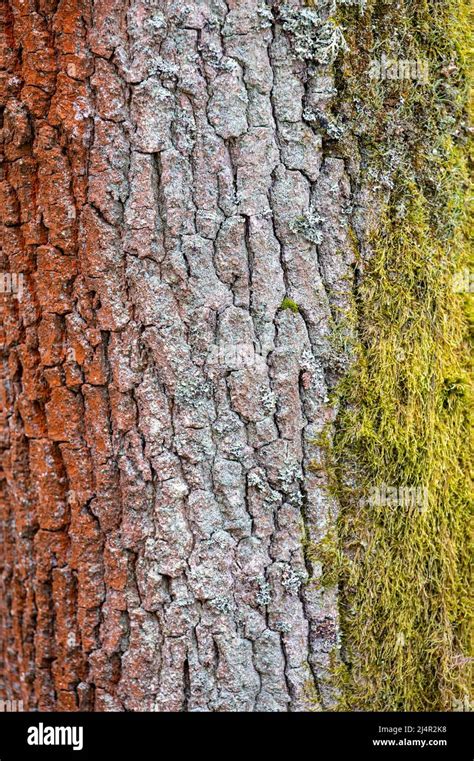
0, 0, 360, 711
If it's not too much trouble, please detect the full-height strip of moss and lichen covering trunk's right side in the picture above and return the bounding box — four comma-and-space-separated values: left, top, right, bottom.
312, 0, 473, 711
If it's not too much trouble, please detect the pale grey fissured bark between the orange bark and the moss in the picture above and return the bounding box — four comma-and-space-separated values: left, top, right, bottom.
100, 0, 352, 711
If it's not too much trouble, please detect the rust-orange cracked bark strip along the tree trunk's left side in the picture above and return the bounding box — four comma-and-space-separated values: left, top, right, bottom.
0, 0, 98, 710
